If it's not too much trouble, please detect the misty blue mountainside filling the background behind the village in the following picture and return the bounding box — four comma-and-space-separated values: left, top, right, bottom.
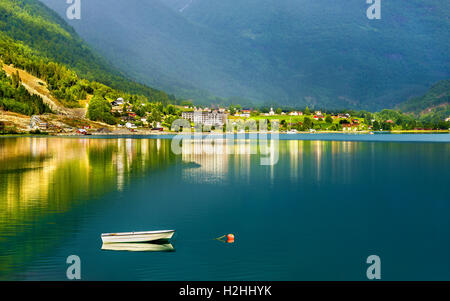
41, 0, 450, 109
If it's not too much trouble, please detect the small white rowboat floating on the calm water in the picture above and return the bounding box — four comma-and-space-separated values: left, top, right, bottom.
102, 230, 175, 243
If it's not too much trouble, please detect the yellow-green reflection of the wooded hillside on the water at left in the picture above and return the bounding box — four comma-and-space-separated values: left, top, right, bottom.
0, 138, 175, 279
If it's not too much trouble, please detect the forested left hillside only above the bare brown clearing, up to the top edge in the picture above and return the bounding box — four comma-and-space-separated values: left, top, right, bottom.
0, 0, 174, 106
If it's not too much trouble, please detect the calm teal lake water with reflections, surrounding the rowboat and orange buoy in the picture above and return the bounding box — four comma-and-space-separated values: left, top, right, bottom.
0, 134, 450, 280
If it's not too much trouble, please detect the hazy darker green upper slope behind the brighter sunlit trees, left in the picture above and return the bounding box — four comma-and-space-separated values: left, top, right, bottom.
0, 0, 172, 101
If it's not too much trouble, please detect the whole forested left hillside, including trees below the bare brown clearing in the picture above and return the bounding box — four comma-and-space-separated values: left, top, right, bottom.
0, 0, 186, 124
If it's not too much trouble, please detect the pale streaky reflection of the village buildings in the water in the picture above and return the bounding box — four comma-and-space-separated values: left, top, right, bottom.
178, 139, 364, 184
